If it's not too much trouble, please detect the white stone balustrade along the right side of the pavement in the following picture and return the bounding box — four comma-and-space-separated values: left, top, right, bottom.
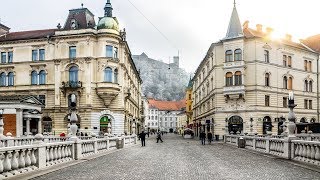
225, 135, 320, 165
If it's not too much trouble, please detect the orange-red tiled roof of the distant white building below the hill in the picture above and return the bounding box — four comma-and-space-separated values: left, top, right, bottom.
149, 99, 186, 111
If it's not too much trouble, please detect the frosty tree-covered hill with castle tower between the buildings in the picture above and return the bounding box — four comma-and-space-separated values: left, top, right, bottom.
132, 53, 189, 101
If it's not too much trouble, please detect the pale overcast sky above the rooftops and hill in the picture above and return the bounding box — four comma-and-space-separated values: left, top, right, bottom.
0, 0, 320, 72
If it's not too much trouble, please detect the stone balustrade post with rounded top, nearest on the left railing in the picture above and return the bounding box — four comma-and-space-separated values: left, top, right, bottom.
34, 134, 47, 169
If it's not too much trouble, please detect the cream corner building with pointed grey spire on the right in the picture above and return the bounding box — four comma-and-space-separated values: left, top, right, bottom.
192, 2, 319, 137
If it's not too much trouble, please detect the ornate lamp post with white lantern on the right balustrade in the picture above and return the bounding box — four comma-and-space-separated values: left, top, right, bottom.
287, 91, 297, 137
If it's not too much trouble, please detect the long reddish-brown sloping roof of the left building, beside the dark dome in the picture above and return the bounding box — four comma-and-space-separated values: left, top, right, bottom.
0, 29, 56, 42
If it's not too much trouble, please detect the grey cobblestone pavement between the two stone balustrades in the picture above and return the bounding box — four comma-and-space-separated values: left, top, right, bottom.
36, 134, 320, 180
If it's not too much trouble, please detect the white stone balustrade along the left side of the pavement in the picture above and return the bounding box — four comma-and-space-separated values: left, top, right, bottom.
0, 134, 137, 179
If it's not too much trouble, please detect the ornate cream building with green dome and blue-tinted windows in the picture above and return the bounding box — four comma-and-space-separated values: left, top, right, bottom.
0, 0, 142, 134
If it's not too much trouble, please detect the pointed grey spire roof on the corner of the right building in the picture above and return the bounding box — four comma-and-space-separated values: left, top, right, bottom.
225, 4, 243, 39
